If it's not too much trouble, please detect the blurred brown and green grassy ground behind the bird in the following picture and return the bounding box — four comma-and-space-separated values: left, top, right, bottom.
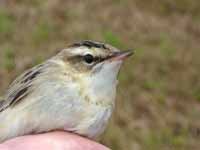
0, 0, 200, 150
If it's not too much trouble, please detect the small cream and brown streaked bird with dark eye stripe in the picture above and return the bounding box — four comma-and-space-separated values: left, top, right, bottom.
0, 40, 133, 143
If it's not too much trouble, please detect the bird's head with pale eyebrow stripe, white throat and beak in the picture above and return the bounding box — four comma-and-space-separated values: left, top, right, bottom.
55, 41, 133, 104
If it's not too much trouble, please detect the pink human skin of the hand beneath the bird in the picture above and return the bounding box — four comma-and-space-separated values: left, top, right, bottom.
0, 131, 109, 150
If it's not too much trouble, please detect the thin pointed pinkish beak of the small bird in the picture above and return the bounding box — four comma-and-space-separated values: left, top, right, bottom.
108, 50, 134, 61
